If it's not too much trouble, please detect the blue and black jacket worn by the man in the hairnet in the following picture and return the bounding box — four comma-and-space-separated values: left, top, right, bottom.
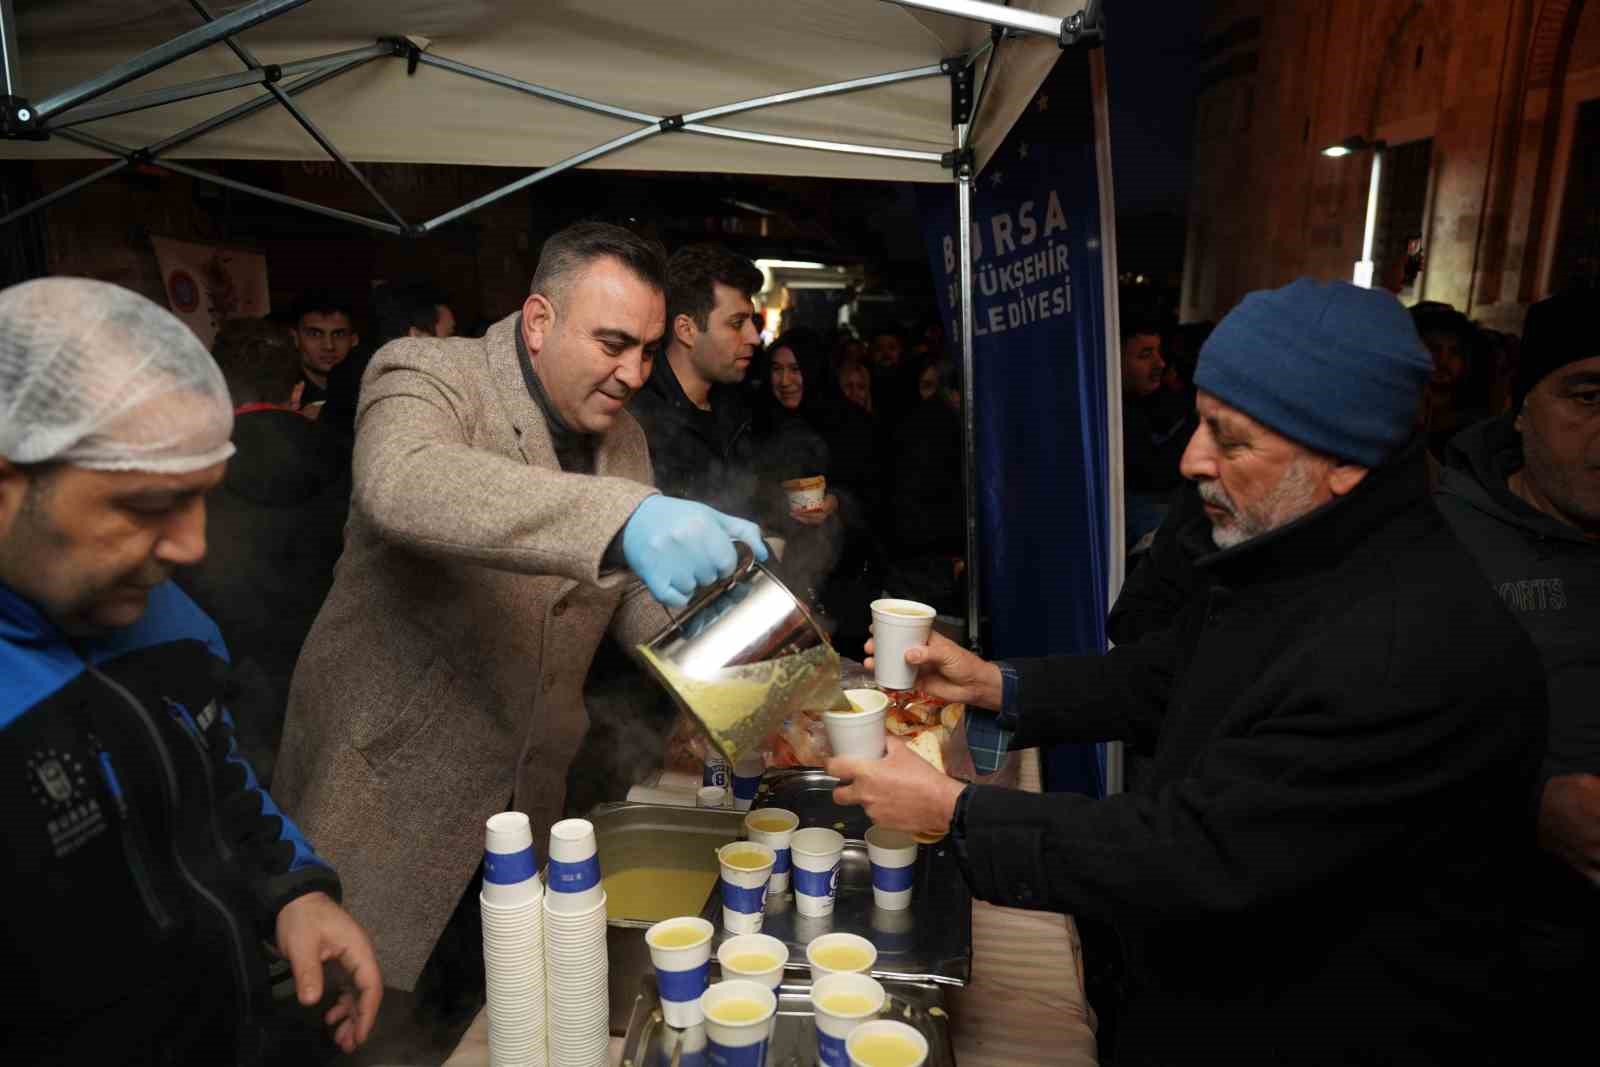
0, 582, 339, 1064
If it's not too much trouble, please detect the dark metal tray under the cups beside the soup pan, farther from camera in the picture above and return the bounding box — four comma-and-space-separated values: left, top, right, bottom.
701, 769, 973, 985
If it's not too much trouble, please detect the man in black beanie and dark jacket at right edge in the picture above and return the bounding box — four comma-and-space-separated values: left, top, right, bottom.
1438, 287, 1600, 1053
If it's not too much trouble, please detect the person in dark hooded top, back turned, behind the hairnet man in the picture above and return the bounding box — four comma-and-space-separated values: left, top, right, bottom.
178, 318, 350, 784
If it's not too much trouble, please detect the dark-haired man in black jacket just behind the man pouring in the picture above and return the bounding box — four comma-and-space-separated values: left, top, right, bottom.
629, 245, 762, 518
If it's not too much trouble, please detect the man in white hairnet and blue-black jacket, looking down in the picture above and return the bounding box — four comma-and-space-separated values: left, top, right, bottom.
0, 278, 382, 1064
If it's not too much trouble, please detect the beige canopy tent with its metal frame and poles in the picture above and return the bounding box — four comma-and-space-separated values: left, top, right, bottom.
0, 0, 1122, 726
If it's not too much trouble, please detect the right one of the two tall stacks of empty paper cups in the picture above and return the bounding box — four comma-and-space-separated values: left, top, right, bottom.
544, 819, 611, 1067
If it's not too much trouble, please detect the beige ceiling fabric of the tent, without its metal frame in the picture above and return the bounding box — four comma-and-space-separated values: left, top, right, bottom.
0, 0, 1082, 181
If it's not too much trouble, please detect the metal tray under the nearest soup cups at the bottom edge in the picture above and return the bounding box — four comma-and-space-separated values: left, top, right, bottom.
622, 963, 955, 1067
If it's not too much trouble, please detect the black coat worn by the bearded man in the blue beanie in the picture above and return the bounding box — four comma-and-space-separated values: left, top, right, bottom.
957, 448, 1546, 1064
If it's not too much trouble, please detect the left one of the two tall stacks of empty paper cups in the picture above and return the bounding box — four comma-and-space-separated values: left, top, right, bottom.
478, 811, 549, 1067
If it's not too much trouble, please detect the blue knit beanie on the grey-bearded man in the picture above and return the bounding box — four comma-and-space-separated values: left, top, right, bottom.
1195, 278, 1434, 467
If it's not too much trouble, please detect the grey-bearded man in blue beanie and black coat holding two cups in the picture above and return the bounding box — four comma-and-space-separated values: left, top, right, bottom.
829, 282, 1546, 1064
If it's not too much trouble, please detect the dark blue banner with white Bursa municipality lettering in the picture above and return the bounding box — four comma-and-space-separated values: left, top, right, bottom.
920, 48, 1112, 795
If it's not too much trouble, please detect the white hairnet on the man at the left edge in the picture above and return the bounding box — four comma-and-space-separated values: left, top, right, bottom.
0, 278, 234, 474
